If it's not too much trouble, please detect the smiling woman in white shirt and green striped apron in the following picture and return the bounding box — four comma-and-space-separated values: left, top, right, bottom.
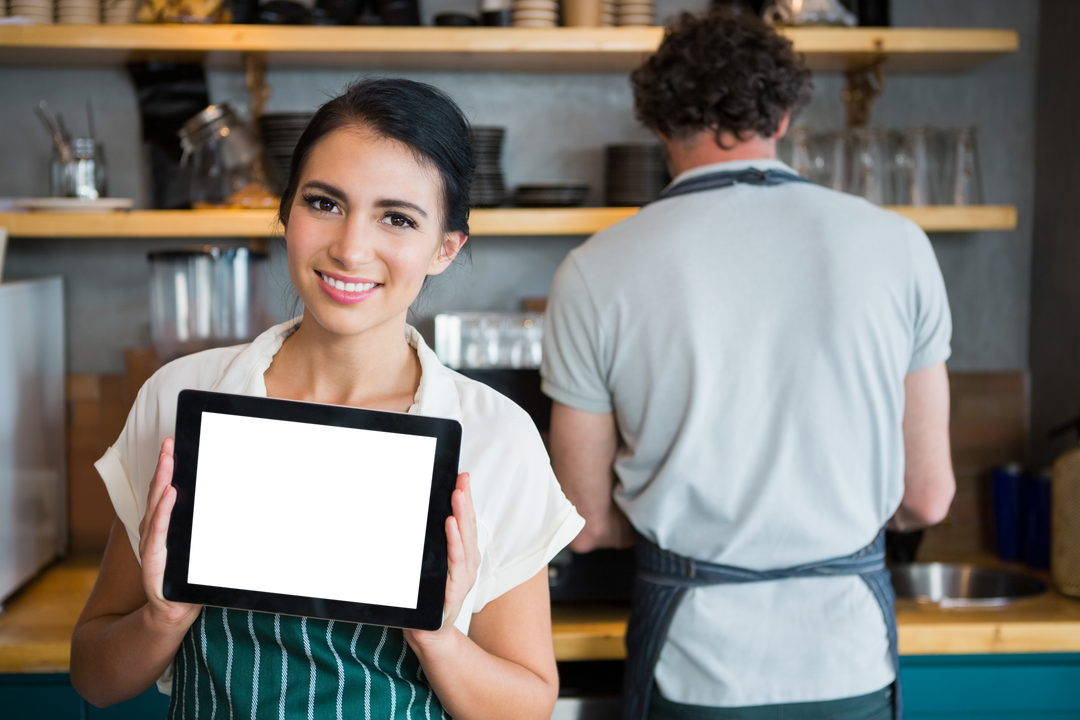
71, 80, 583, 719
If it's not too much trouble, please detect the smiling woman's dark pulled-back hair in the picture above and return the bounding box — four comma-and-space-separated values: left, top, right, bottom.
278, 79, 474, 234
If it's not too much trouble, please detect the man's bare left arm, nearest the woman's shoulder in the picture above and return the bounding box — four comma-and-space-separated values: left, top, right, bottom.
551, 403, 634, 553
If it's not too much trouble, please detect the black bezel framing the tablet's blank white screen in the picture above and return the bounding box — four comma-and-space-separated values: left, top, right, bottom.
163, 390, 461, 630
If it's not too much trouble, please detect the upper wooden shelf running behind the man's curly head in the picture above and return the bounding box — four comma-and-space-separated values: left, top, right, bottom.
0, 25, 1020, 72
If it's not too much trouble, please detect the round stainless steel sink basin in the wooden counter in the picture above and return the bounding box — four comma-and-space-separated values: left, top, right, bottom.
889, 562, 1047, 608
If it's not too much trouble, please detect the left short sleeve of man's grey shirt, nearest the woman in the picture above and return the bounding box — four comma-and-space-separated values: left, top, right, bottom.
540, 253, 612, 412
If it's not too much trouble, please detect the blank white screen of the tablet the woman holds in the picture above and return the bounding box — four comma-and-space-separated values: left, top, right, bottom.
191, 415, 434, 606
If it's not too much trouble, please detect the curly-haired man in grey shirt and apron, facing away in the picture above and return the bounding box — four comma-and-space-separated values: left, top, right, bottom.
542, 5, 955, 720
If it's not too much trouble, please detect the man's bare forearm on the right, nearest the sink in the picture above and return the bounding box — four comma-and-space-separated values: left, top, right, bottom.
889, 363, 956, 530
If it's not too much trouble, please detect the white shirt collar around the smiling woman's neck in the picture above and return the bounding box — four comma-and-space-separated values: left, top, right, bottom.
211, 315, 461, 422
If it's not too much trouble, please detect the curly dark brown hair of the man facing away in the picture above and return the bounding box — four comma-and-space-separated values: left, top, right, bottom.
630, 8, 813, 147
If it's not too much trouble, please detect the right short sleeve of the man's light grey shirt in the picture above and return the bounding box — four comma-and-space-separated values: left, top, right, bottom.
907, 223, 953, 372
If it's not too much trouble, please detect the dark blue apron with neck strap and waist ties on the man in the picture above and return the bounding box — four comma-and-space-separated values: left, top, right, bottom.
622, 167, 903, 720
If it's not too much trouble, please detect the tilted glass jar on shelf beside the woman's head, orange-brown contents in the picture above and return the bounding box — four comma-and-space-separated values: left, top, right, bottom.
179, 103, 276, 208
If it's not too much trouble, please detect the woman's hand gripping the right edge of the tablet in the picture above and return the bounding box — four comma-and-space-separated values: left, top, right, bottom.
405, 473, 480, 650
